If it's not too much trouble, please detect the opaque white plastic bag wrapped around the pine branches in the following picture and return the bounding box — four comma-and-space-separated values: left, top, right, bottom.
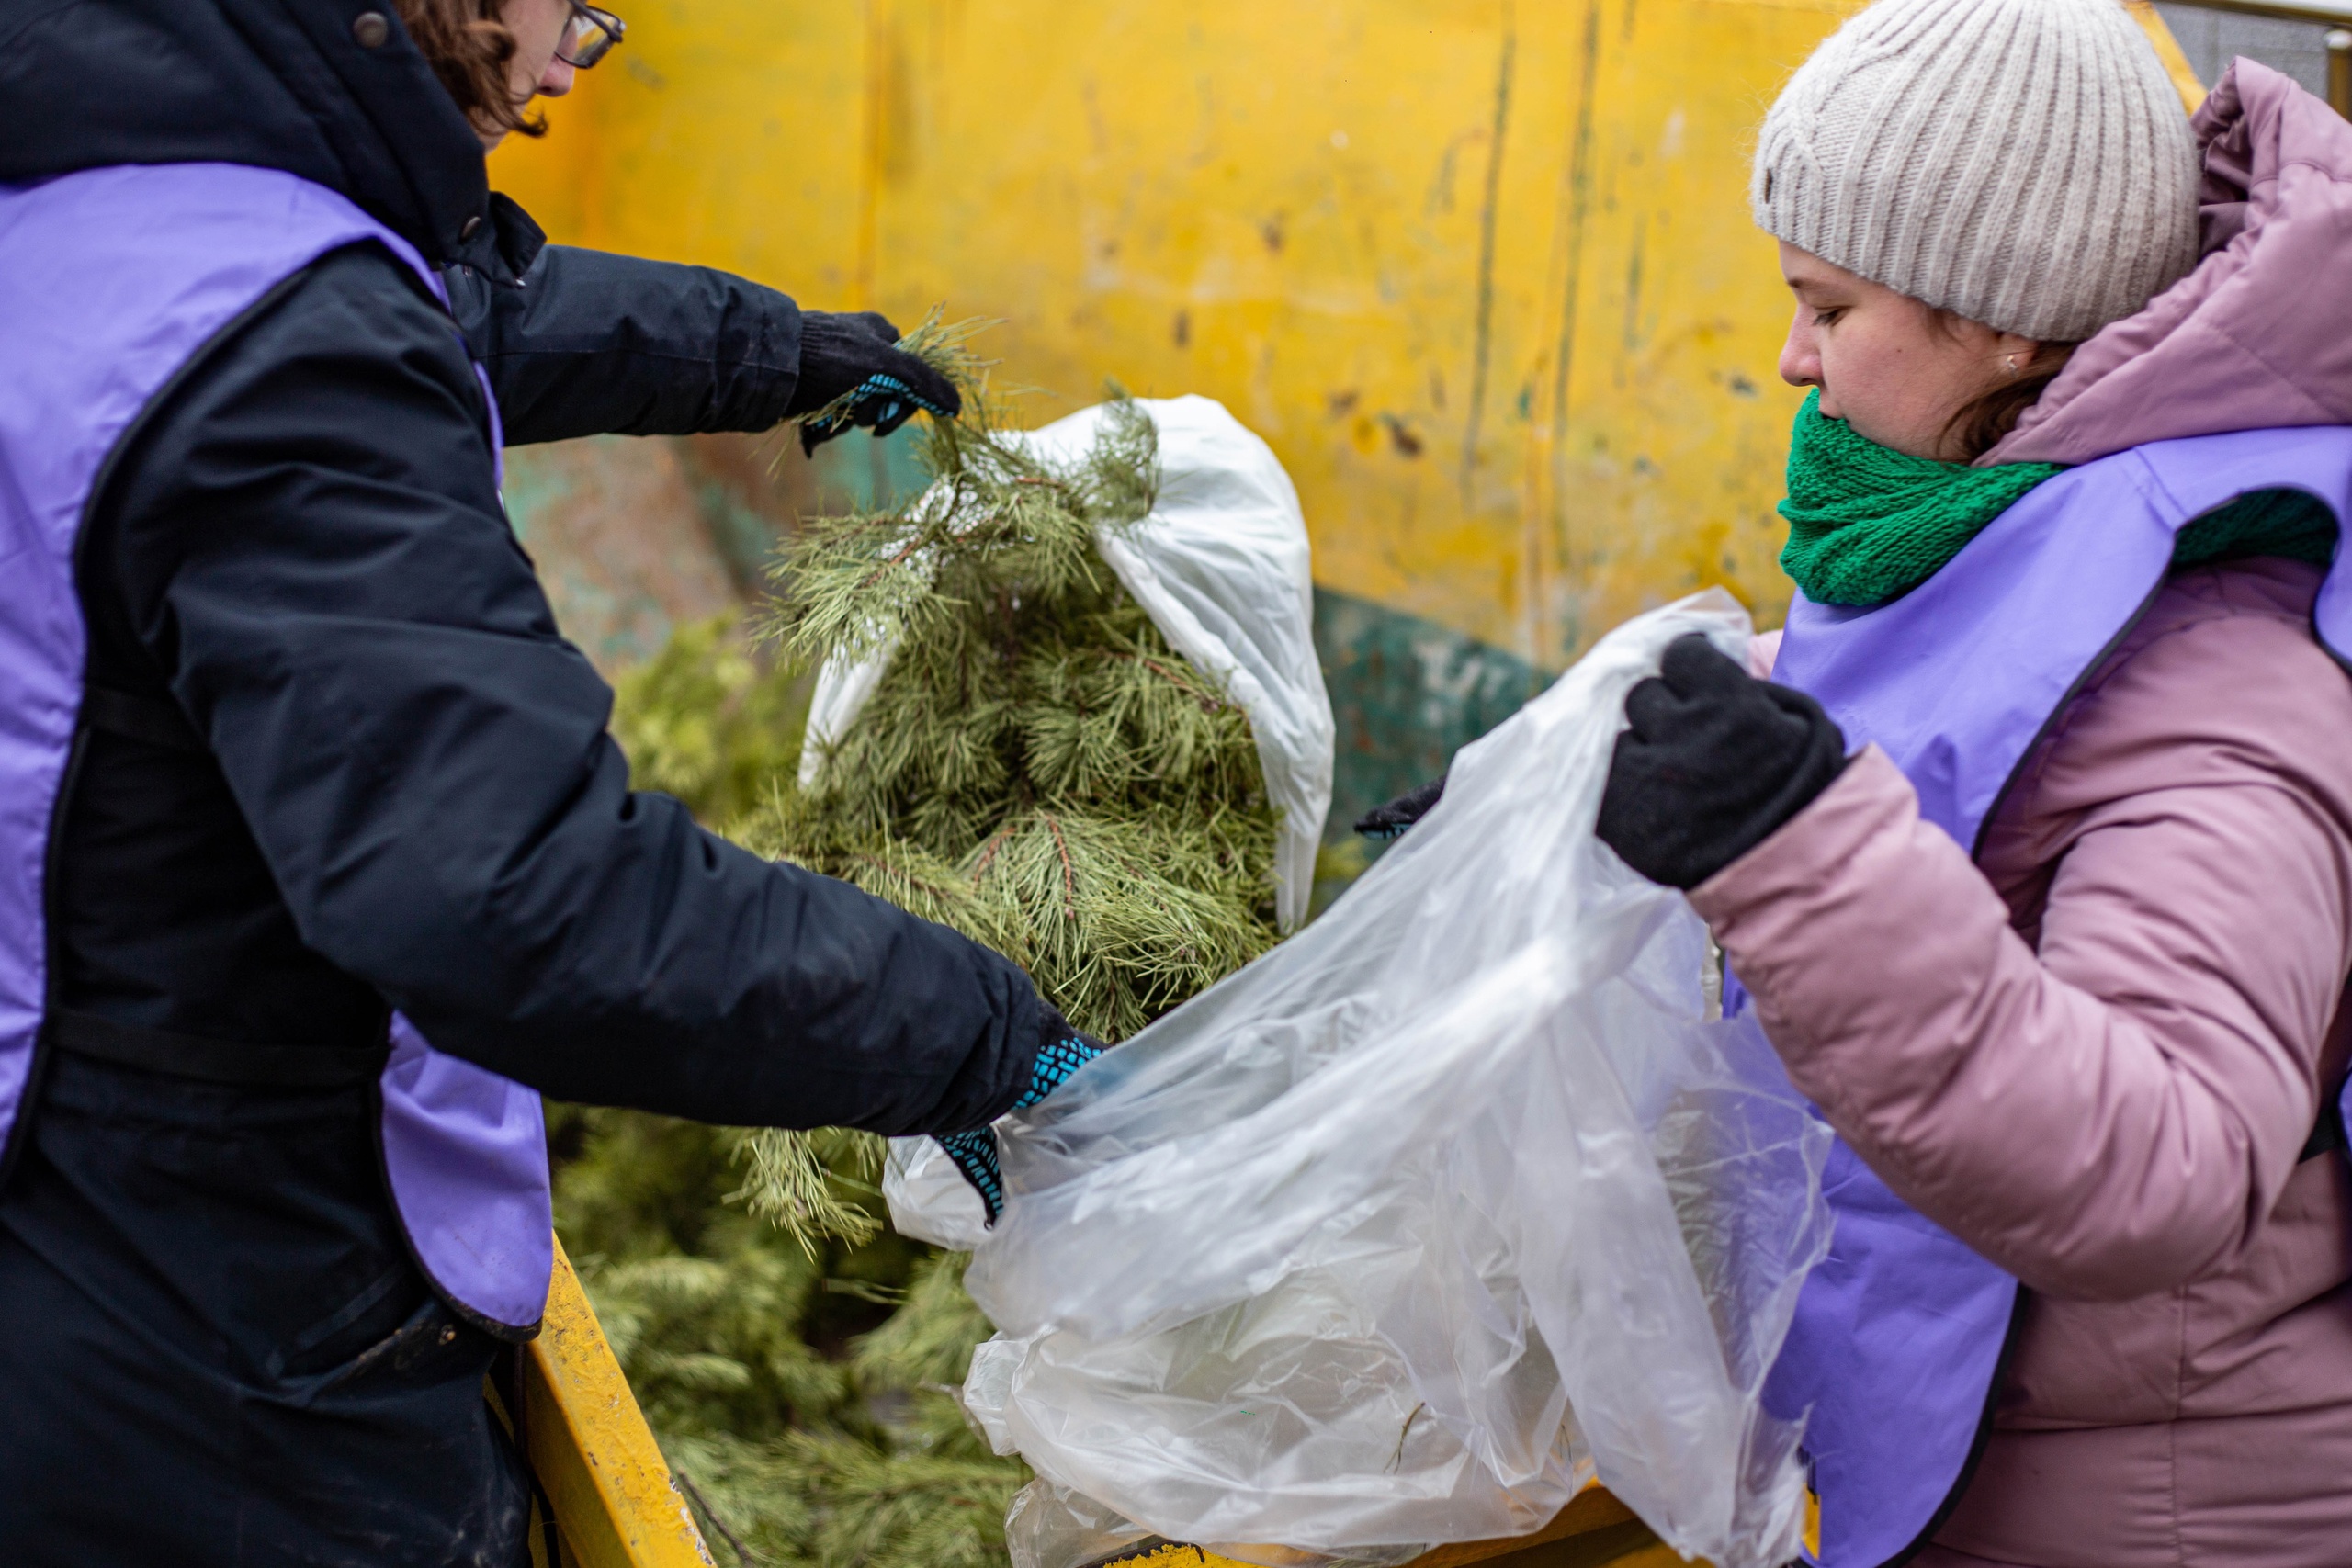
799, 398, 1334, 931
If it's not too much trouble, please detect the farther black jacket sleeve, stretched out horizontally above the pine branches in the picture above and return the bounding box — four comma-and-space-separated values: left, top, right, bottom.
442, 244, 799, 446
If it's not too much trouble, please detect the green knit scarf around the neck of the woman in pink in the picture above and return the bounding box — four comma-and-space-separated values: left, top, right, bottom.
1781, 388, 2335, 604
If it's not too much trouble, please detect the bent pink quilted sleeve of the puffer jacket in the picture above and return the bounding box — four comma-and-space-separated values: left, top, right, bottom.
1691, 606, 2352, 1300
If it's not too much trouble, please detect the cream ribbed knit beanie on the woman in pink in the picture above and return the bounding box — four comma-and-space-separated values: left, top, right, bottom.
1750, 0, 2197, 344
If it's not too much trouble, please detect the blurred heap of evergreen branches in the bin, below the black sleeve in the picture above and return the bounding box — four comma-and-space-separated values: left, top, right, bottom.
555, 1110, 1028, 1568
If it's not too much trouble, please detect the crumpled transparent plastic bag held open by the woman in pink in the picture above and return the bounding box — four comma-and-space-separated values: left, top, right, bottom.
891, 592, 1830, 1568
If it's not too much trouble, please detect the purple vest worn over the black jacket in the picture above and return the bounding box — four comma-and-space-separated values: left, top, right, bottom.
0, 164, 553, 1337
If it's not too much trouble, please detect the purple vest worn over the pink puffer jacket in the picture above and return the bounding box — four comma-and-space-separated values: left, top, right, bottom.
1767, 425, 2352, 1568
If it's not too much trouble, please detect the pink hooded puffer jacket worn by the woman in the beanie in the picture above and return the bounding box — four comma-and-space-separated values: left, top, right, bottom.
1691, 62, 2352, 1568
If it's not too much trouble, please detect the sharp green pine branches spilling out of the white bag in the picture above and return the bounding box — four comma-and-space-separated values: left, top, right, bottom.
734, 345, 1275, 1248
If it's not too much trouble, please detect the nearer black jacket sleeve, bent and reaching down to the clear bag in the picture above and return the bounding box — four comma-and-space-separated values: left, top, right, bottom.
101, 249, 1045, 1134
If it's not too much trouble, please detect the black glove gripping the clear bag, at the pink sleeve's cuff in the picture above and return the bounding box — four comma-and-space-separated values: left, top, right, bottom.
1595, 632, 1847, 888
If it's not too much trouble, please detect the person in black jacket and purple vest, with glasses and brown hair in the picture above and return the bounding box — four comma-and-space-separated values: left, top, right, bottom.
0, 0, 1087, 1563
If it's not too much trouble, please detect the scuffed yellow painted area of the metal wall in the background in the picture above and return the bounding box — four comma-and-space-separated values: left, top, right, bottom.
494, 0, 1851, 668
